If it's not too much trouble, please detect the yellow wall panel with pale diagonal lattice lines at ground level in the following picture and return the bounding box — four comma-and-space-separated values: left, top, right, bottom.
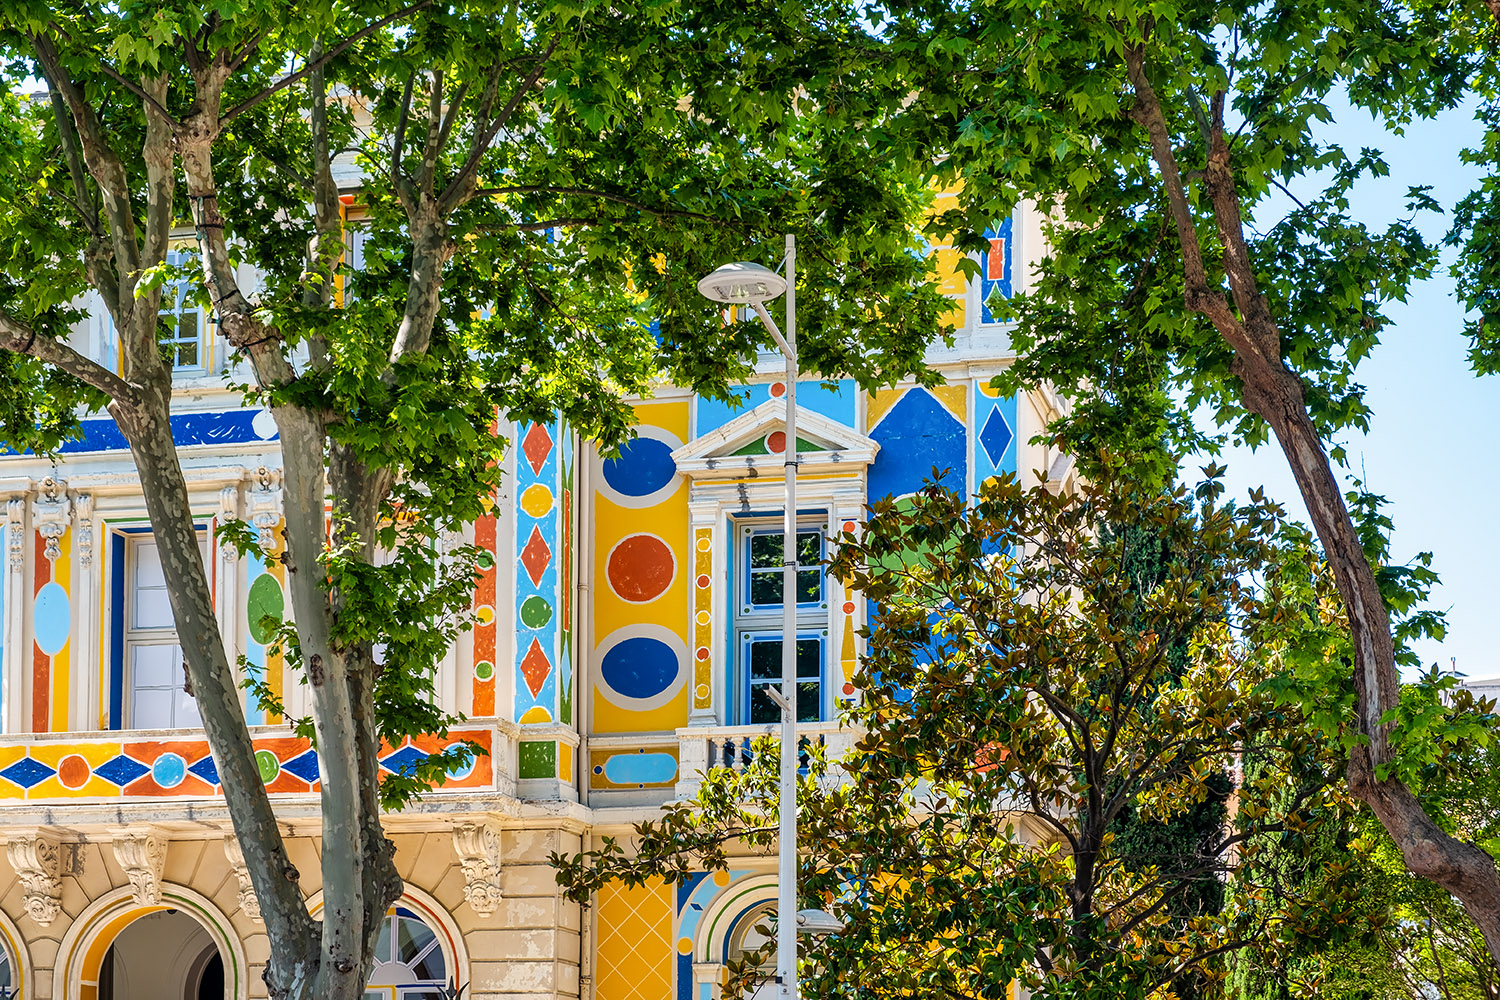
596, 882, 674, 1000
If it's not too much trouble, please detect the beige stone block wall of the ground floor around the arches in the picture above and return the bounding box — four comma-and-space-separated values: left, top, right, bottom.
0, 828, 582, 1000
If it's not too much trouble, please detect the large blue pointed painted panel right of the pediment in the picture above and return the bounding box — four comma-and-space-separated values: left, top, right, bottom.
869, 388, 969, 502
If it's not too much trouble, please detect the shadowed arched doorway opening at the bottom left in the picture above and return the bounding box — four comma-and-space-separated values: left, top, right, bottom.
96, 909, 225, 1000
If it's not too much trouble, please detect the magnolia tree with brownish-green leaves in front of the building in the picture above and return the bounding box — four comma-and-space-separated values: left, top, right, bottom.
554, 477, 1358, 1000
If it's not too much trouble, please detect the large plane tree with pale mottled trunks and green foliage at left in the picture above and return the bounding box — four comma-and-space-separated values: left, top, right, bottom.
0, 0, 941, 1000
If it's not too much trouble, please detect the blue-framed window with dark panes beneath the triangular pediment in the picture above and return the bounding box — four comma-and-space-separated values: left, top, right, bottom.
735, 520, 828, 726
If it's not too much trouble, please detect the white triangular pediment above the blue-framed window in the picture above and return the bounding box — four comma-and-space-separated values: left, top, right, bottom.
672, 399, 881, 478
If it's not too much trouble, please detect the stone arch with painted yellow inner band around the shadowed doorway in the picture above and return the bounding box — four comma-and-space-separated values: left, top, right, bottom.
53, 882, 251, 1000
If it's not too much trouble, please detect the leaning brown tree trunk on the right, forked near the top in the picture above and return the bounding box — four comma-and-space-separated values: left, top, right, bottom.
1125, 46, 1500, 963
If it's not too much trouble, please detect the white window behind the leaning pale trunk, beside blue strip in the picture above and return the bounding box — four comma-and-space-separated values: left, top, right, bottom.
123, 535, 209, 729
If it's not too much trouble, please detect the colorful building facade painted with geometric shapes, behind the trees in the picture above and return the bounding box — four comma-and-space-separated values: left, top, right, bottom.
0, 206, 1062, 1000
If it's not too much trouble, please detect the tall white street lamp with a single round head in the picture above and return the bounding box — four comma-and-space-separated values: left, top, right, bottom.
698, 234, 804, 1000
